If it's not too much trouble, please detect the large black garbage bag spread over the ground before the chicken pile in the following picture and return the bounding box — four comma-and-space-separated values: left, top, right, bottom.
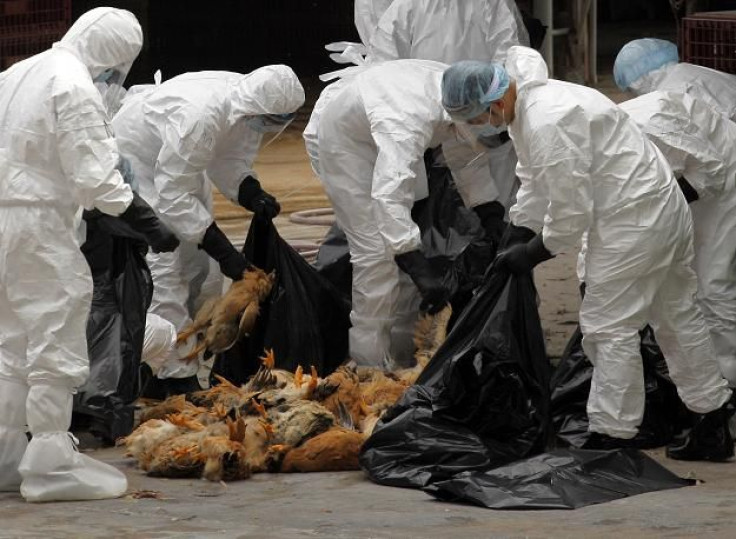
360, 273, 692, 509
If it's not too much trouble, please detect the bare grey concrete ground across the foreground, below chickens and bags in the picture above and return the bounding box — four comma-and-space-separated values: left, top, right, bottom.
0, 449, 736, 539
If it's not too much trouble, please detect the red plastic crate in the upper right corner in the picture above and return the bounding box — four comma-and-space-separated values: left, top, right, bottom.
681, 11, 736, 73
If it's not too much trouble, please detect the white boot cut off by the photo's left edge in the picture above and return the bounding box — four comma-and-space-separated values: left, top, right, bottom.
0, 377, 28, 492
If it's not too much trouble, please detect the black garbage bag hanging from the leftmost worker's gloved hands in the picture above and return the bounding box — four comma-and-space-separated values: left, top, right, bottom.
73, 216, 153, 443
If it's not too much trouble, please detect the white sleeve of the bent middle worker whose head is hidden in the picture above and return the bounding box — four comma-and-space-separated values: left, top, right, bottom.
370, 115, 432, 254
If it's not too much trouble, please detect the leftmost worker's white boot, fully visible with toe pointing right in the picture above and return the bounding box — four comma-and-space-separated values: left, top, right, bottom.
19, 385, 128, 502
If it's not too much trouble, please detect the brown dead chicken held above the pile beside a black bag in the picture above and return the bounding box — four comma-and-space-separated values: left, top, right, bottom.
177, 268, 275, 361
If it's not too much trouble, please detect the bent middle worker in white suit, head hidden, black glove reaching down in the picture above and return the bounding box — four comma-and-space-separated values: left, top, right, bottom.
305, 60, 468, 367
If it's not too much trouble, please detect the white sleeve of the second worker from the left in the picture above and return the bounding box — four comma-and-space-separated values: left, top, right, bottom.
154, 112, 214, 243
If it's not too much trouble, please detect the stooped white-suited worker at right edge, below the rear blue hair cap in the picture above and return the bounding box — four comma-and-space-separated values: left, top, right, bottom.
619, 92, 736, 387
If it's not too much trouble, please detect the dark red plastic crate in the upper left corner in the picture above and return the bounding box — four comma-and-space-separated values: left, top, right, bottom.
0, 0, 72, 70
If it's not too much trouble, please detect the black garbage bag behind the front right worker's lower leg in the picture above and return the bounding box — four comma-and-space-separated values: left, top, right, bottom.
551, 326, 689, 448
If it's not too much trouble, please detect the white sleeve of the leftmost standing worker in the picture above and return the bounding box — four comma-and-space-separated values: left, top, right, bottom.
54, 76, 133, 215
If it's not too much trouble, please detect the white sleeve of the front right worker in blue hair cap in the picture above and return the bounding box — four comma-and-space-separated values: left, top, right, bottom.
528, 124, 593, 254
